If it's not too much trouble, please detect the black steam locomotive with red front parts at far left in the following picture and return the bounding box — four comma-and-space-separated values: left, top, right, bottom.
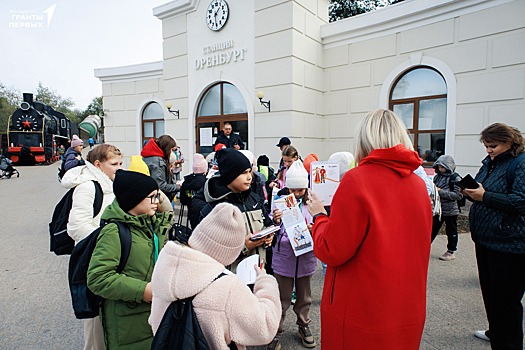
3, 93, 78, 164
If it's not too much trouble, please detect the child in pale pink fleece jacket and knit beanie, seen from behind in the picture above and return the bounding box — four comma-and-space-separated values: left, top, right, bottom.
148, 204, 280, 349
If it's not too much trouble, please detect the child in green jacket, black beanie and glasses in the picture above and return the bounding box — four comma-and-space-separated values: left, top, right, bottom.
88, 170, 172, 350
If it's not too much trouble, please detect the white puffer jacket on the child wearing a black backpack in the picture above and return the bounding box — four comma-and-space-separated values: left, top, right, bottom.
62, 161, 115, 243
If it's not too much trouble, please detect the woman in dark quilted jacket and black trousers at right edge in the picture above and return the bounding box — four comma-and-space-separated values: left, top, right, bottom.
463, 123, 525, 349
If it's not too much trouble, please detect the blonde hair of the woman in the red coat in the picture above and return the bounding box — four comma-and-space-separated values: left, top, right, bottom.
355, 109, 414, 163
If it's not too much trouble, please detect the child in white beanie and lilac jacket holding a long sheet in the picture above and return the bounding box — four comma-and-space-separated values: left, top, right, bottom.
272, 160, 317, 348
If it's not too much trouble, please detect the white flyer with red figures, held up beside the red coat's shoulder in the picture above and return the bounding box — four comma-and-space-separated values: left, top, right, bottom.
310, 162, 341, 206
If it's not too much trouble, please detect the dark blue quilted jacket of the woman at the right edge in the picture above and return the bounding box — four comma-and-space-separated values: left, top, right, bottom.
469, 152, 525, 254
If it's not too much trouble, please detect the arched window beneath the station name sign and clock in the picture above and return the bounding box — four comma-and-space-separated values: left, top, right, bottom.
195, 82, 248, 156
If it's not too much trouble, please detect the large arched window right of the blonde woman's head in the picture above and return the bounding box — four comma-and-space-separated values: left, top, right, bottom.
390, 67, 447, 165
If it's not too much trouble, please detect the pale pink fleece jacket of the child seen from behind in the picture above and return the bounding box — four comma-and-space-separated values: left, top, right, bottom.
149, 241, 281, 350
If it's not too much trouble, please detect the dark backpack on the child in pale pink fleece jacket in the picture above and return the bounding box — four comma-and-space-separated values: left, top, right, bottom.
151, 273, 237, 350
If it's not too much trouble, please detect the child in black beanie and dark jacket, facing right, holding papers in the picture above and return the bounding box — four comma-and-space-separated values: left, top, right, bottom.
190, 148, 273, 272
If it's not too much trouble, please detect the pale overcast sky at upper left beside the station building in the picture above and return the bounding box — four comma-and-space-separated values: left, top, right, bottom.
0, 0, 169, 110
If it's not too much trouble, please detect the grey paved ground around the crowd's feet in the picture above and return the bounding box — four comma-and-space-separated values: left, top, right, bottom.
0, 163, 516, 350
